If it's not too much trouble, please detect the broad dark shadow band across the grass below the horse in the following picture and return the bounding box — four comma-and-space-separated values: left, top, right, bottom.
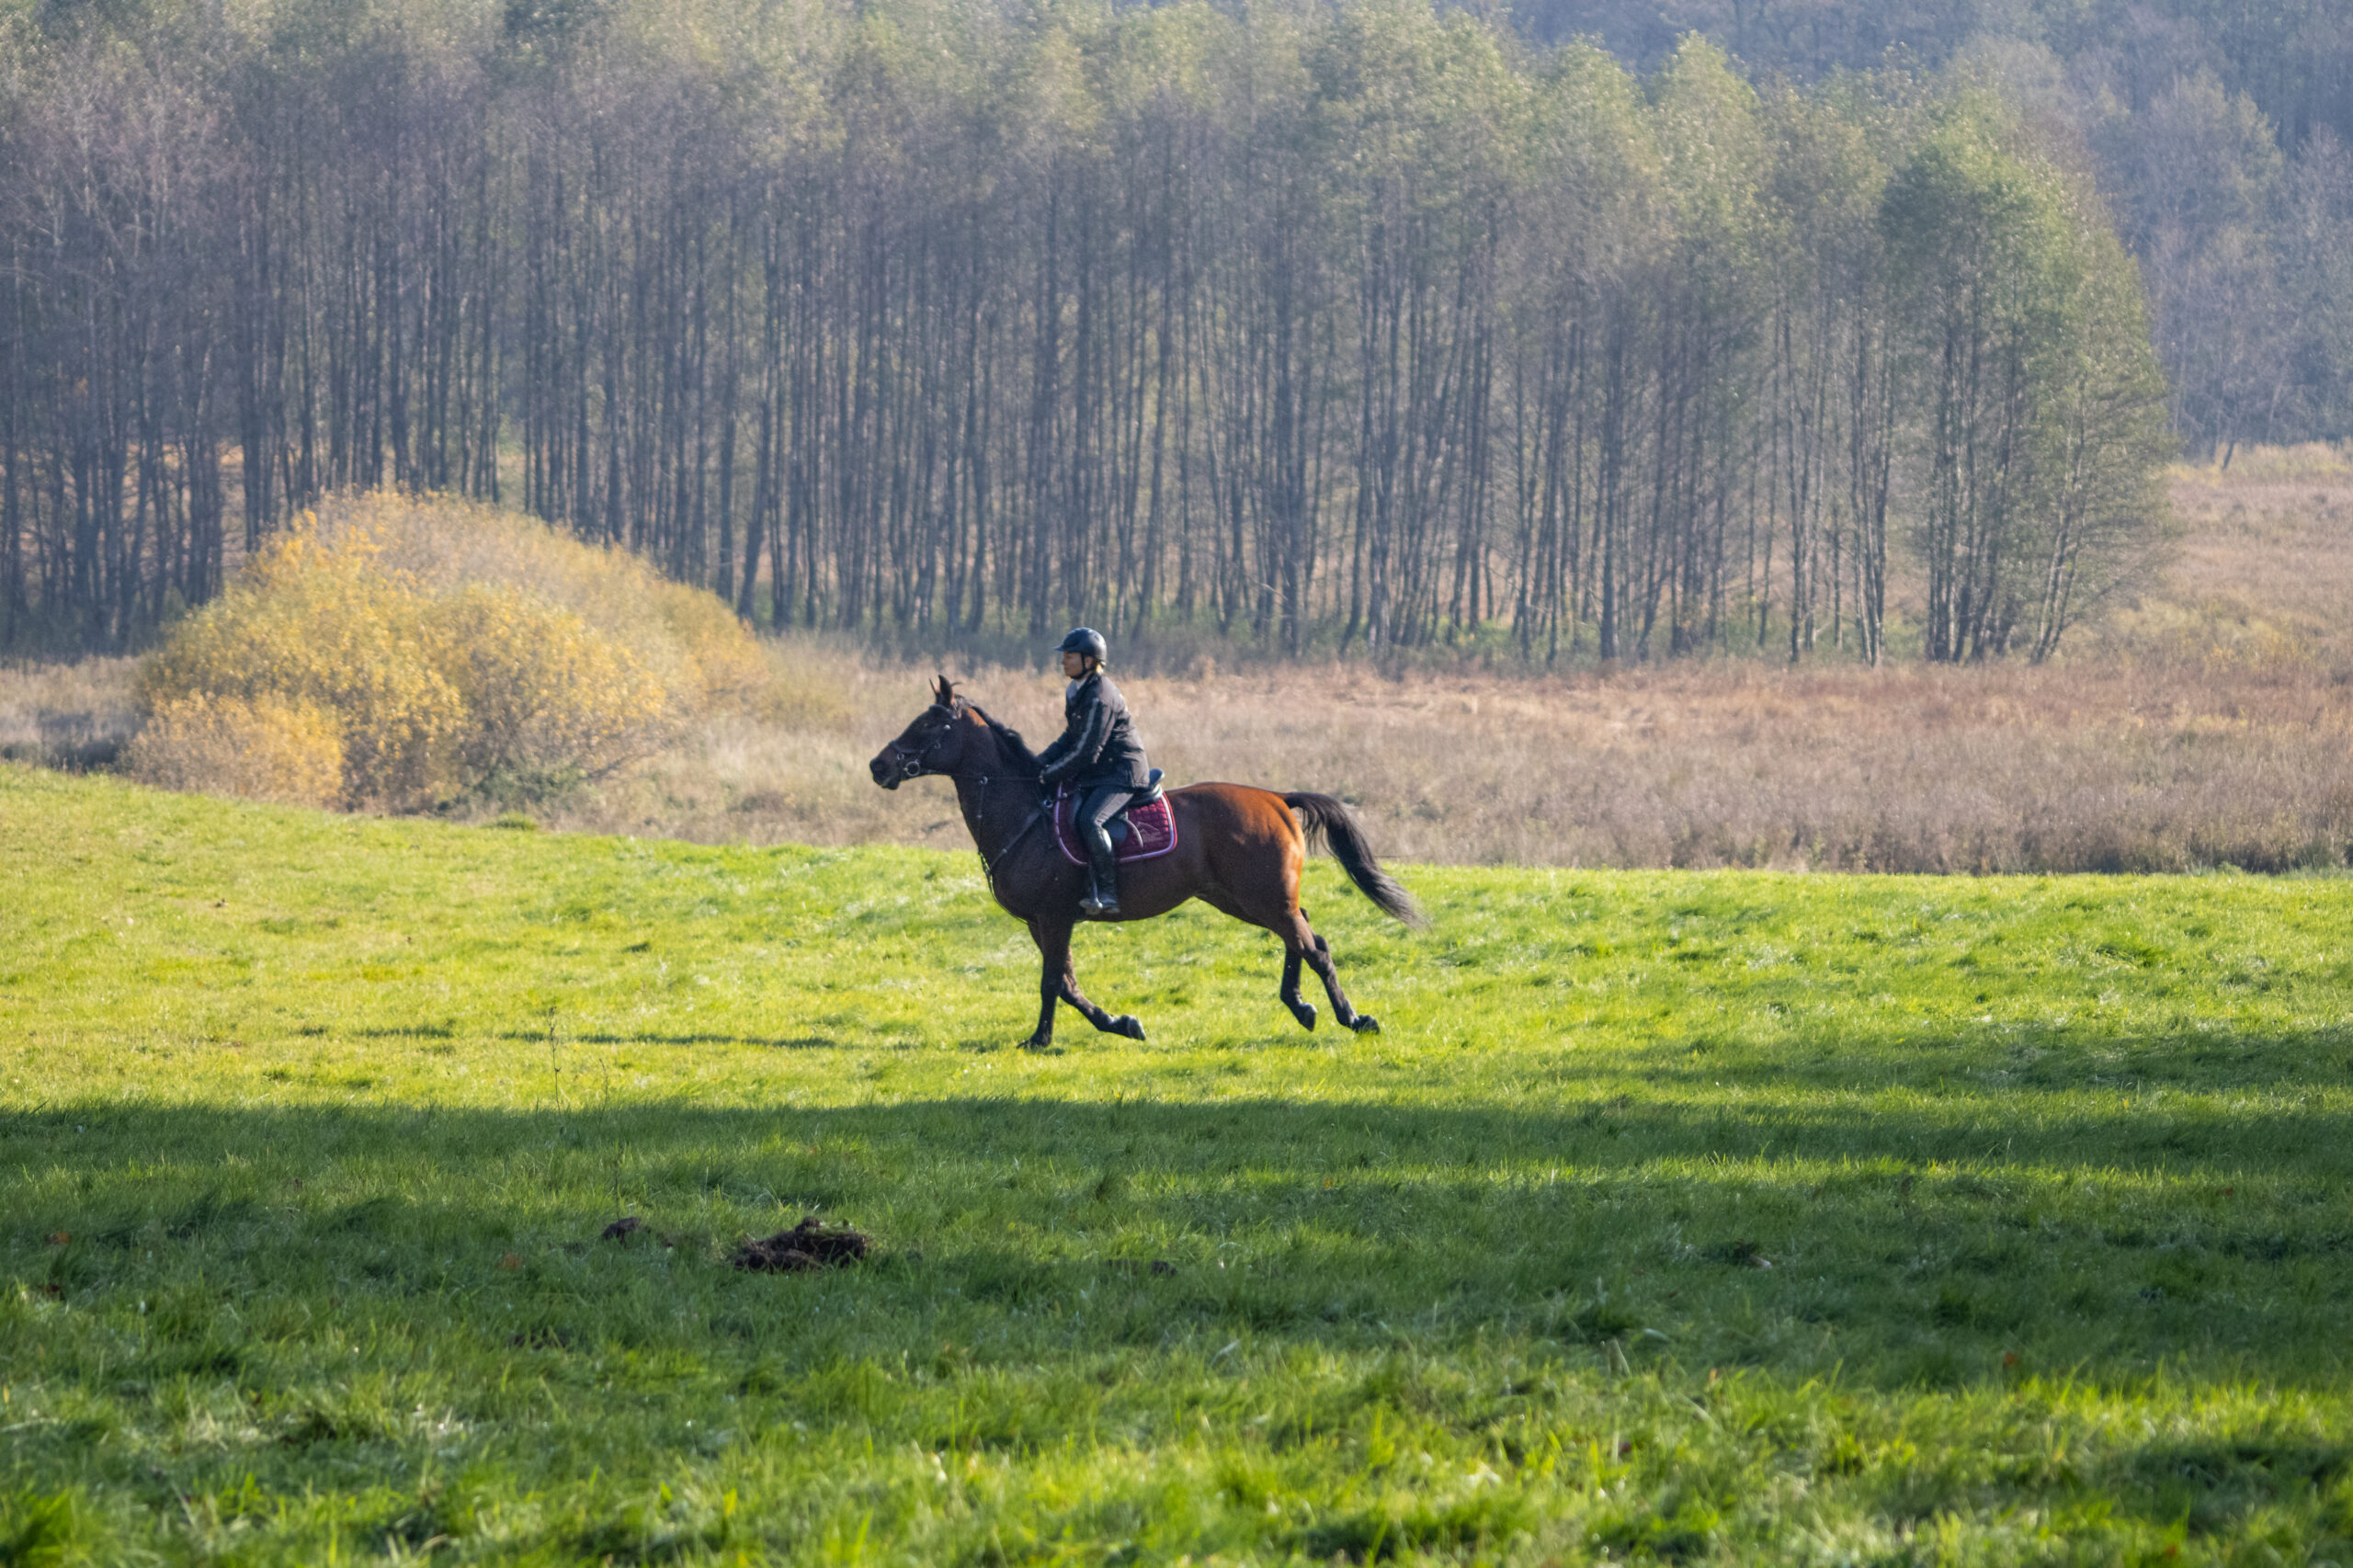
0, 1074, 2353, 1387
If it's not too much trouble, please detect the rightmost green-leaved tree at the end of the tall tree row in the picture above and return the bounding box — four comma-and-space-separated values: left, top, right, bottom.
1882, 116, 2167, 659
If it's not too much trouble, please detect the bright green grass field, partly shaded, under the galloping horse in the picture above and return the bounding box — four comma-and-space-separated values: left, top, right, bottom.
0, 767, 2353, 1563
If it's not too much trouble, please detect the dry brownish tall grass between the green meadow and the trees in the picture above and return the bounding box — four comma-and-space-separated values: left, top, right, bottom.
14, 449, 2353, 871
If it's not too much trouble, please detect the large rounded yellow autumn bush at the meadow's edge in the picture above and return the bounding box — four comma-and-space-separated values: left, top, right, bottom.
139, 492, 767, 808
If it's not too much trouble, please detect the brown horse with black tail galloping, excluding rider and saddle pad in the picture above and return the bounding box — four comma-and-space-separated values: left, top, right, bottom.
869, 676, 1424, 1050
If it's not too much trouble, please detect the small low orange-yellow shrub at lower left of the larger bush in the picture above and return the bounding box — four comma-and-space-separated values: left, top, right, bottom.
125, 692, 344, 805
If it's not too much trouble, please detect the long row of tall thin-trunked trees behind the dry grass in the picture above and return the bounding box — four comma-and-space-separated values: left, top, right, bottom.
0, 0, 2169, 659
